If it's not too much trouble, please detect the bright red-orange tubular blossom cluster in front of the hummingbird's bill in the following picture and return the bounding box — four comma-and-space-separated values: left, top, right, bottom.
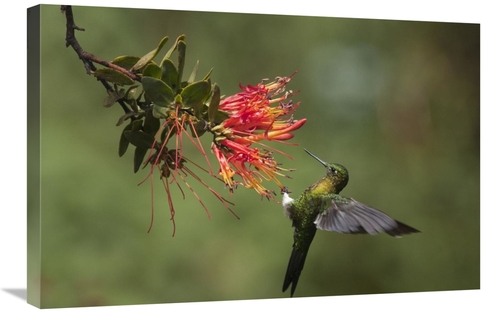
212, 75, 306, 198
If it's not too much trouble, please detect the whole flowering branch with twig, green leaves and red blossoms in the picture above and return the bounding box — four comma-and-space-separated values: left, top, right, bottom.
68, 25, 306, 233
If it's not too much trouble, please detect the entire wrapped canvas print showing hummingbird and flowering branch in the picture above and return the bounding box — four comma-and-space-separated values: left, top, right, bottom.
27, 5, 480, 308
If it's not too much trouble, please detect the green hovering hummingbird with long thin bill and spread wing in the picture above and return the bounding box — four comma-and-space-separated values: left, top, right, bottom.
281, 149, 420, 297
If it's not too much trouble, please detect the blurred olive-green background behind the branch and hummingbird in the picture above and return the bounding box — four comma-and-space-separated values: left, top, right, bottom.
28, 5, 480, 307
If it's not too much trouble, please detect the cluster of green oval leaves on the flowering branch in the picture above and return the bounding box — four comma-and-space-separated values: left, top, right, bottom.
93, 35, 227, 172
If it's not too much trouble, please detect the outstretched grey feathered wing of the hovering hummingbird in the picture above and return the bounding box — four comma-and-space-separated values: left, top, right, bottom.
314, 194, 420, 237
